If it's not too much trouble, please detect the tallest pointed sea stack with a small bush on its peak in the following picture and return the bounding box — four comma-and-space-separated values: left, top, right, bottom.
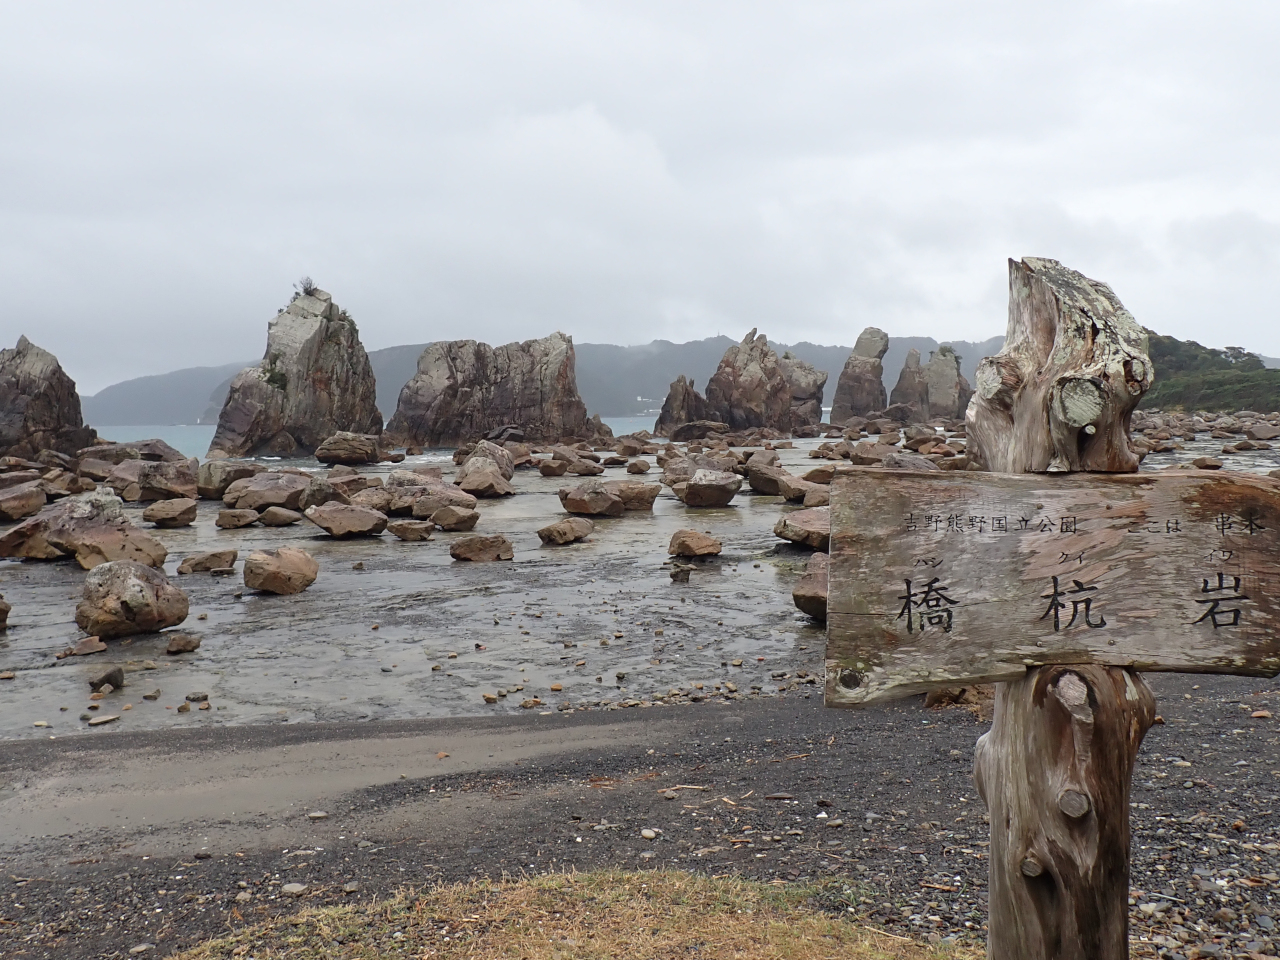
209, 285, 383, 458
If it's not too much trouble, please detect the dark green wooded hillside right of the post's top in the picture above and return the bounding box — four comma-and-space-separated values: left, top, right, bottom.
1142, 330, 1280, 412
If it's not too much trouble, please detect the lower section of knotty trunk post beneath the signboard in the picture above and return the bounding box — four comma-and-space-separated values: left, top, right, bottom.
974, 666, 1156, 960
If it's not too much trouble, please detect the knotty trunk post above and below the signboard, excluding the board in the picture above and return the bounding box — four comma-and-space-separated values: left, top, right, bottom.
965, 257, 1155, 960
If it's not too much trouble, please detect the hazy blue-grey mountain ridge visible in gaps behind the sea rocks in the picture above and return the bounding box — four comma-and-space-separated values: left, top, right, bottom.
81, 337, 1005, 426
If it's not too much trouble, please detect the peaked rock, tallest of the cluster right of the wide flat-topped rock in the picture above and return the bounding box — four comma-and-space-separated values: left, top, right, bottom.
707, 328, 791, 430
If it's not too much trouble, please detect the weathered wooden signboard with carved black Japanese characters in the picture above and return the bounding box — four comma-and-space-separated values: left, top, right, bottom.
826, 468, 1280, 707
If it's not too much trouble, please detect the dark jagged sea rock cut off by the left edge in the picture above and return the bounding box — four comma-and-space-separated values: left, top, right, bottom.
0, 337, 97, 460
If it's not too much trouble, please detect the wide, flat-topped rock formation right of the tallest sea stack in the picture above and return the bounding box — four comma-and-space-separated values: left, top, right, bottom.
387, 332, 594, 447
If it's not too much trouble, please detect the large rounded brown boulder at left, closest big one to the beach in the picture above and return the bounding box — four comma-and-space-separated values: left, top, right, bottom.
76, 561, 187, 640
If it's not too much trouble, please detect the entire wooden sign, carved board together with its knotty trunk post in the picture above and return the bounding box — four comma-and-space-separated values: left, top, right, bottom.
827, 260, 1280, 960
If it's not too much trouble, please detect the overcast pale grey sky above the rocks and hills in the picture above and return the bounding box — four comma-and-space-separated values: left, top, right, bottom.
0, 0, 1280, 393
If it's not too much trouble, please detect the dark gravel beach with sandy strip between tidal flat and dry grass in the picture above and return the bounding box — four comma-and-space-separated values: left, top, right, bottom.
0, 675, 1280, 960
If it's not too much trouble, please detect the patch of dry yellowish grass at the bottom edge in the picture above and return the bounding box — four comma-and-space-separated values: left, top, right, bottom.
177, 870, 979, 960
